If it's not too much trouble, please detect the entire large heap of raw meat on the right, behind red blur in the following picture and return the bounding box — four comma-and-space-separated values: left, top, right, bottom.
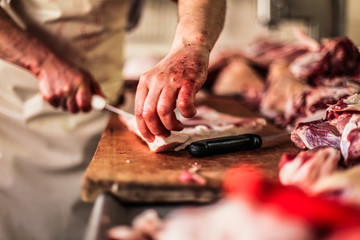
207, 32, 360, 212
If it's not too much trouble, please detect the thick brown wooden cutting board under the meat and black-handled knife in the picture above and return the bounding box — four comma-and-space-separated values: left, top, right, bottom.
82, 97, 299, 202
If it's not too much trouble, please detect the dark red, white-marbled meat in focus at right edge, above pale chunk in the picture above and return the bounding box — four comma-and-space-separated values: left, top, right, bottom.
291, 94, 360, 166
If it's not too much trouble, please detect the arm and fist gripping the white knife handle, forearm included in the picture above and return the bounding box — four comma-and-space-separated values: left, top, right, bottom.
0, 8, 103, 113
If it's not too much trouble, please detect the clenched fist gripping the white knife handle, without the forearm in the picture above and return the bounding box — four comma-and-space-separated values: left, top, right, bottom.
36, 56, 104, 113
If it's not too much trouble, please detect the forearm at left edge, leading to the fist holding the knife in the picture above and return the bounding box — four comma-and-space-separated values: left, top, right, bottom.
0, 8, 53, 74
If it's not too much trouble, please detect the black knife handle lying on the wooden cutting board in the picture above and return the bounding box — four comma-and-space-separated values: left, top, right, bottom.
189, 134, 262, 157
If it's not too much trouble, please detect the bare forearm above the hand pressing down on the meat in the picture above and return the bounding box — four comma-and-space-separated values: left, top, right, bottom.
172, 0, 226, 52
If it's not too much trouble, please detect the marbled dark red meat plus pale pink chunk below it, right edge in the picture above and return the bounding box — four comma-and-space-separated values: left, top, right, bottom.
279, 94, 360, 207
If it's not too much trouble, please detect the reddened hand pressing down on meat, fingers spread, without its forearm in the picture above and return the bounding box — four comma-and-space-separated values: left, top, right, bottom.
135, 44, 210, 142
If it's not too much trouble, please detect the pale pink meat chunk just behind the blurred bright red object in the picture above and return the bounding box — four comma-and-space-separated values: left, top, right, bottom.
279, 147, 341, 191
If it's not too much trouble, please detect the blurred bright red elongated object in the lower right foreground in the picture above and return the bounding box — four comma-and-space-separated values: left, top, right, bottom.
223, 166, 360, 240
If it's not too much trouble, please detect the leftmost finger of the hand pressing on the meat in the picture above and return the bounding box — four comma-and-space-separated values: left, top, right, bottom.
134, 84, 155, 142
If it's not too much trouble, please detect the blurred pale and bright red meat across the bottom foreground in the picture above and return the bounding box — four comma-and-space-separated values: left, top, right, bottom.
107, 166, 360, 240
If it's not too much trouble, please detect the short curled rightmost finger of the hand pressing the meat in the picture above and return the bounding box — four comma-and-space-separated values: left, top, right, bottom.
177, 85, 196, 118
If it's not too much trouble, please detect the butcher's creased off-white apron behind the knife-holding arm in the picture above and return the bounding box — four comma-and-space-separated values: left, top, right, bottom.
0, 0, 129, 240
